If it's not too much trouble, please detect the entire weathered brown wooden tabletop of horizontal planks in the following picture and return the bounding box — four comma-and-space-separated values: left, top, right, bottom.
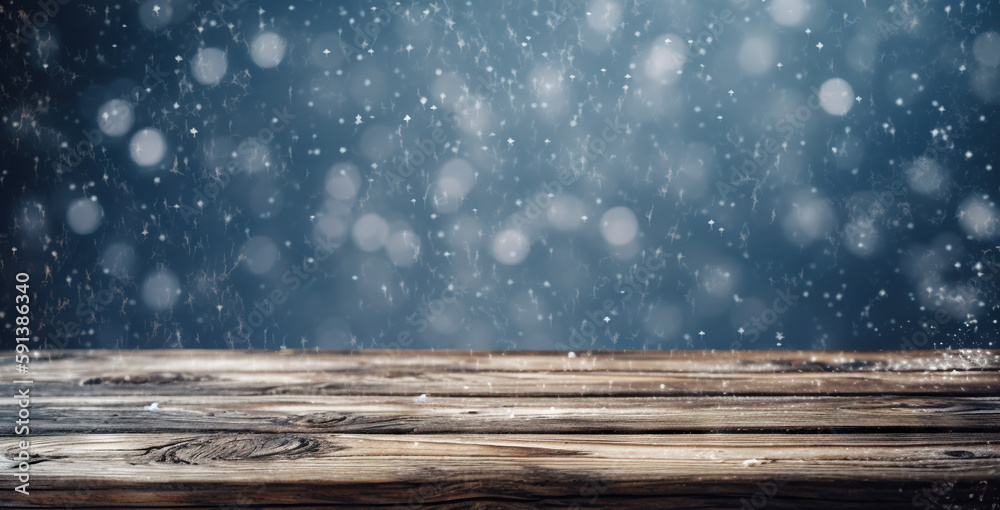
0, 350, 1000, 510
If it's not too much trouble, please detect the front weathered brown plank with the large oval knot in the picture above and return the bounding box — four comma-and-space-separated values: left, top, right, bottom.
0, 434, 1000, 504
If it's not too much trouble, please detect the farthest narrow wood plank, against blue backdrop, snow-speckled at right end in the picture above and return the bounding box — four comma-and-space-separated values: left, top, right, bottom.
15, 349, 1000, 372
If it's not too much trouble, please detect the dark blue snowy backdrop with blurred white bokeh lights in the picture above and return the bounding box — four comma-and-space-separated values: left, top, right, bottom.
0, 0, 1000, 350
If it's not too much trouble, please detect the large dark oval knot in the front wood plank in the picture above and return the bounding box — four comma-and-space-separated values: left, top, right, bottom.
143, 434, 320, 464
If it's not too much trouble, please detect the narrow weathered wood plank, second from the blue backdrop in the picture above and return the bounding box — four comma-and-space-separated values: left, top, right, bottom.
27, 370, 1000, 398
